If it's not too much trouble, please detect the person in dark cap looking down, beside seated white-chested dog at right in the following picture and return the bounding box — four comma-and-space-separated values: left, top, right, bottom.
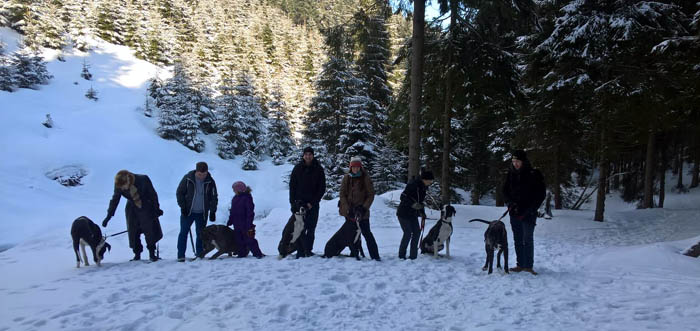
396, 171, 435, 260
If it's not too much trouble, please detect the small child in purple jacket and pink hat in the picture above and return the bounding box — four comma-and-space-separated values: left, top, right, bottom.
226, 181, 265, 259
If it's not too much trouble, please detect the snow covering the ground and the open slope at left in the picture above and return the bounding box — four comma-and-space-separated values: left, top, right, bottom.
0, 29, 700, 330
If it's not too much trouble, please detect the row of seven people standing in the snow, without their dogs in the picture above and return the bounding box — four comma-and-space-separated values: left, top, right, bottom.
102, 147, 545, 274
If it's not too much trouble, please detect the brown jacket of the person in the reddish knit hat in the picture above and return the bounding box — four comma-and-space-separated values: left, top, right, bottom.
338, 168, 374, 220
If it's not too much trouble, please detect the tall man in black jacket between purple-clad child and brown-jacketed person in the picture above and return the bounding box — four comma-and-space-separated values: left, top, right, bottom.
289, 147, 326, 257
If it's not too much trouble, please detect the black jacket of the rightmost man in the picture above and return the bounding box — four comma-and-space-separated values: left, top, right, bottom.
503, 162, 546, 220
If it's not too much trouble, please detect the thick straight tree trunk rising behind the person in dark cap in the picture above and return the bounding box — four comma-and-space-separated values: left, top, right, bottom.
408, 0, 425, 180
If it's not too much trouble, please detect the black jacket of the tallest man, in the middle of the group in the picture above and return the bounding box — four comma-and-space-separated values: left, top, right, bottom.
289, 159, 326, 207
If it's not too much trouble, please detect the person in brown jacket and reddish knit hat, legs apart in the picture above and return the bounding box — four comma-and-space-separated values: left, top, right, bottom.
338, 157, 381, 261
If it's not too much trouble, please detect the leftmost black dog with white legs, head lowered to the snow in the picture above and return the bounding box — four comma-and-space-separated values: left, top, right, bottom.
70, 216, 112, 268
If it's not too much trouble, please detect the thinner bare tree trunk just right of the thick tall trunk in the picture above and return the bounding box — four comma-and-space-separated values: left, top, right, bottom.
440, 0, 459, 203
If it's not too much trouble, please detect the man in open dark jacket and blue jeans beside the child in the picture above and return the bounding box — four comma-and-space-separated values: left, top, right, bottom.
175, 162, 219, 262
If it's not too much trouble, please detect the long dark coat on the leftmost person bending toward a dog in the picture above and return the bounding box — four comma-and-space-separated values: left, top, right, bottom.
107, 174, 163, 247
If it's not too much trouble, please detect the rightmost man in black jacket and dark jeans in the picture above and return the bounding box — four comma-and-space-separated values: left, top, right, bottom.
503, 150, 546, 275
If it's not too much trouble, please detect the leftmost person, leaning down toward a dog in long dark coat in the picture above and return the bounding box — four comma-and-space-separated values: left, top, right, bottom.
102, 170, 163, 261
